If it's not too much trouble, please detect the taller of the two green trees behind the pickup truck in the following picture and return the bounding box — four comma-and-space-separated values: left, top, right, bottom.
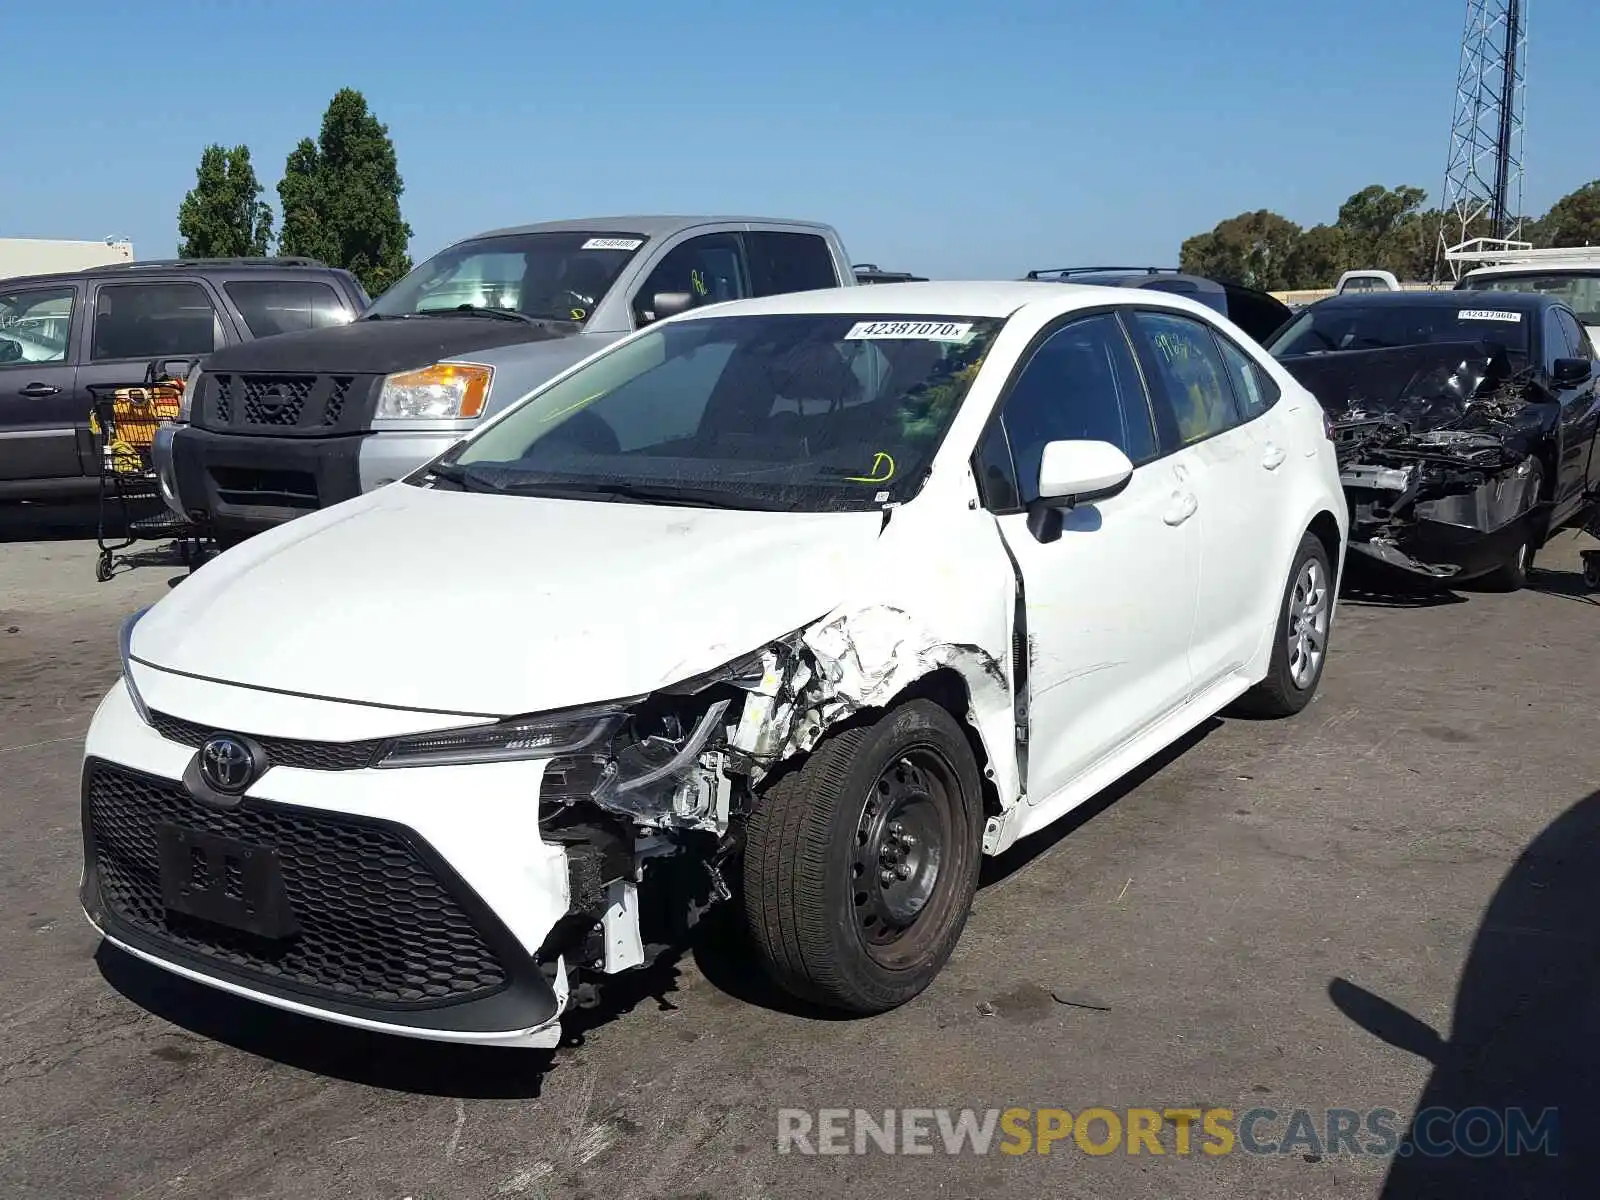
278, 88, 411, 296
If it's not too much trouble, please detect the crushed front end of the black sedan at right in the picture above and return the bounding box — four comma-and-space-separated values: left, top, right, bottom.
1280, 339, 1560, 579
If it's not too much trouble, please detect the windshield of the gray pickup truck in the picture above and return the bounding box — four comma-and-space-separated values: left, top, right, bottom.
365, 230, 646, 322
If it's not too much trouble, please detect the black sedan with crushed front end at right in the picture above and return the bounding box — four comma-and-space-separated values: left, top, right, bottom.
1267, 291, 1600, 590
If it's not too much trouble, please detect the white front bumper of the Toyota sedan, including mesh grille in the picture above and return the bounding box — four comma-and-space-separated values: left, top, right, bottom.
80, 678, 568, 1048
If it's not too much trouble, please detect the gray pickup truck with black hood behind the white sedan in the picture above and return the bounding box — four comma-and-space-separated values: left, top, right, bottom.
155, 216, 856, 546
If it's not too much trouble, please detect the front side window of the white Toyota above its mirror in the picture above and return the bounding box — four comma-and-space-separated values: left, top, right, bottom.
1000, 312, 1157, 504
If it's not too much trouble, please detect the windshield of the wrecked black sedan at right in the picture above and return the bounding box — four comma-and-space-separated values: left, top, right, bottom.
1267, 298, 1533, 360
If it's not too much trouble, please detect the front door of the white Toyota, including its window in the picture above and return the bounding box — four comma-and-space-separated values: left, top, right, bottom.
979, 312, 1200, 805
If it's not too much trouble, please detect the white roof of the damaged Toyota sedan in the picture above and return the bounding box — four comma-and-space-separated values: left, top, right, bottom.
675, 280, 1198, 318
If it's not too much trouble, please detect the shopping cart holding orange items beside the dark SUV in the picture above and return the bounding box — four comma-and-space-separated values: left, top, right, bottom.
88, 360, 202, 582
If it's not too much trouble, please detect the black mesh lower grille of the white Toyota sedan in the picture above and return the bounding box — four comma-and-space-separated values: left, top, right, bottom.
85, 762, 507, 1008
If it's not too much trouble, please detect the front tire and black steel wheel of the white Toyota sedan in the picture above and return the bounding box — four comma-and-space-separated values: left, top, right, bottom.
744, 699, 984, 1014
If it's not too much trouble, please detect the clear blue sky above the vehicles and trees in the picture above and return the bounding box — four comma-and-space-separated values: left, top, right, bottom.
0, 0, 1600, 278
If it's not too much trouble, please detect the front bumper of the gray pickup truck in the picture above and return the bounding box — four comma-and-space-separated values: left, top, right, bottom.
170, 426, 462, 533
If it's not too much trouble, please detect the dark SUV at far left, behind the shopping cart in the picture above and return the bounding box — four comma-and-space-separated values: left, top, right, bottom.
0, 258, 370, 499
